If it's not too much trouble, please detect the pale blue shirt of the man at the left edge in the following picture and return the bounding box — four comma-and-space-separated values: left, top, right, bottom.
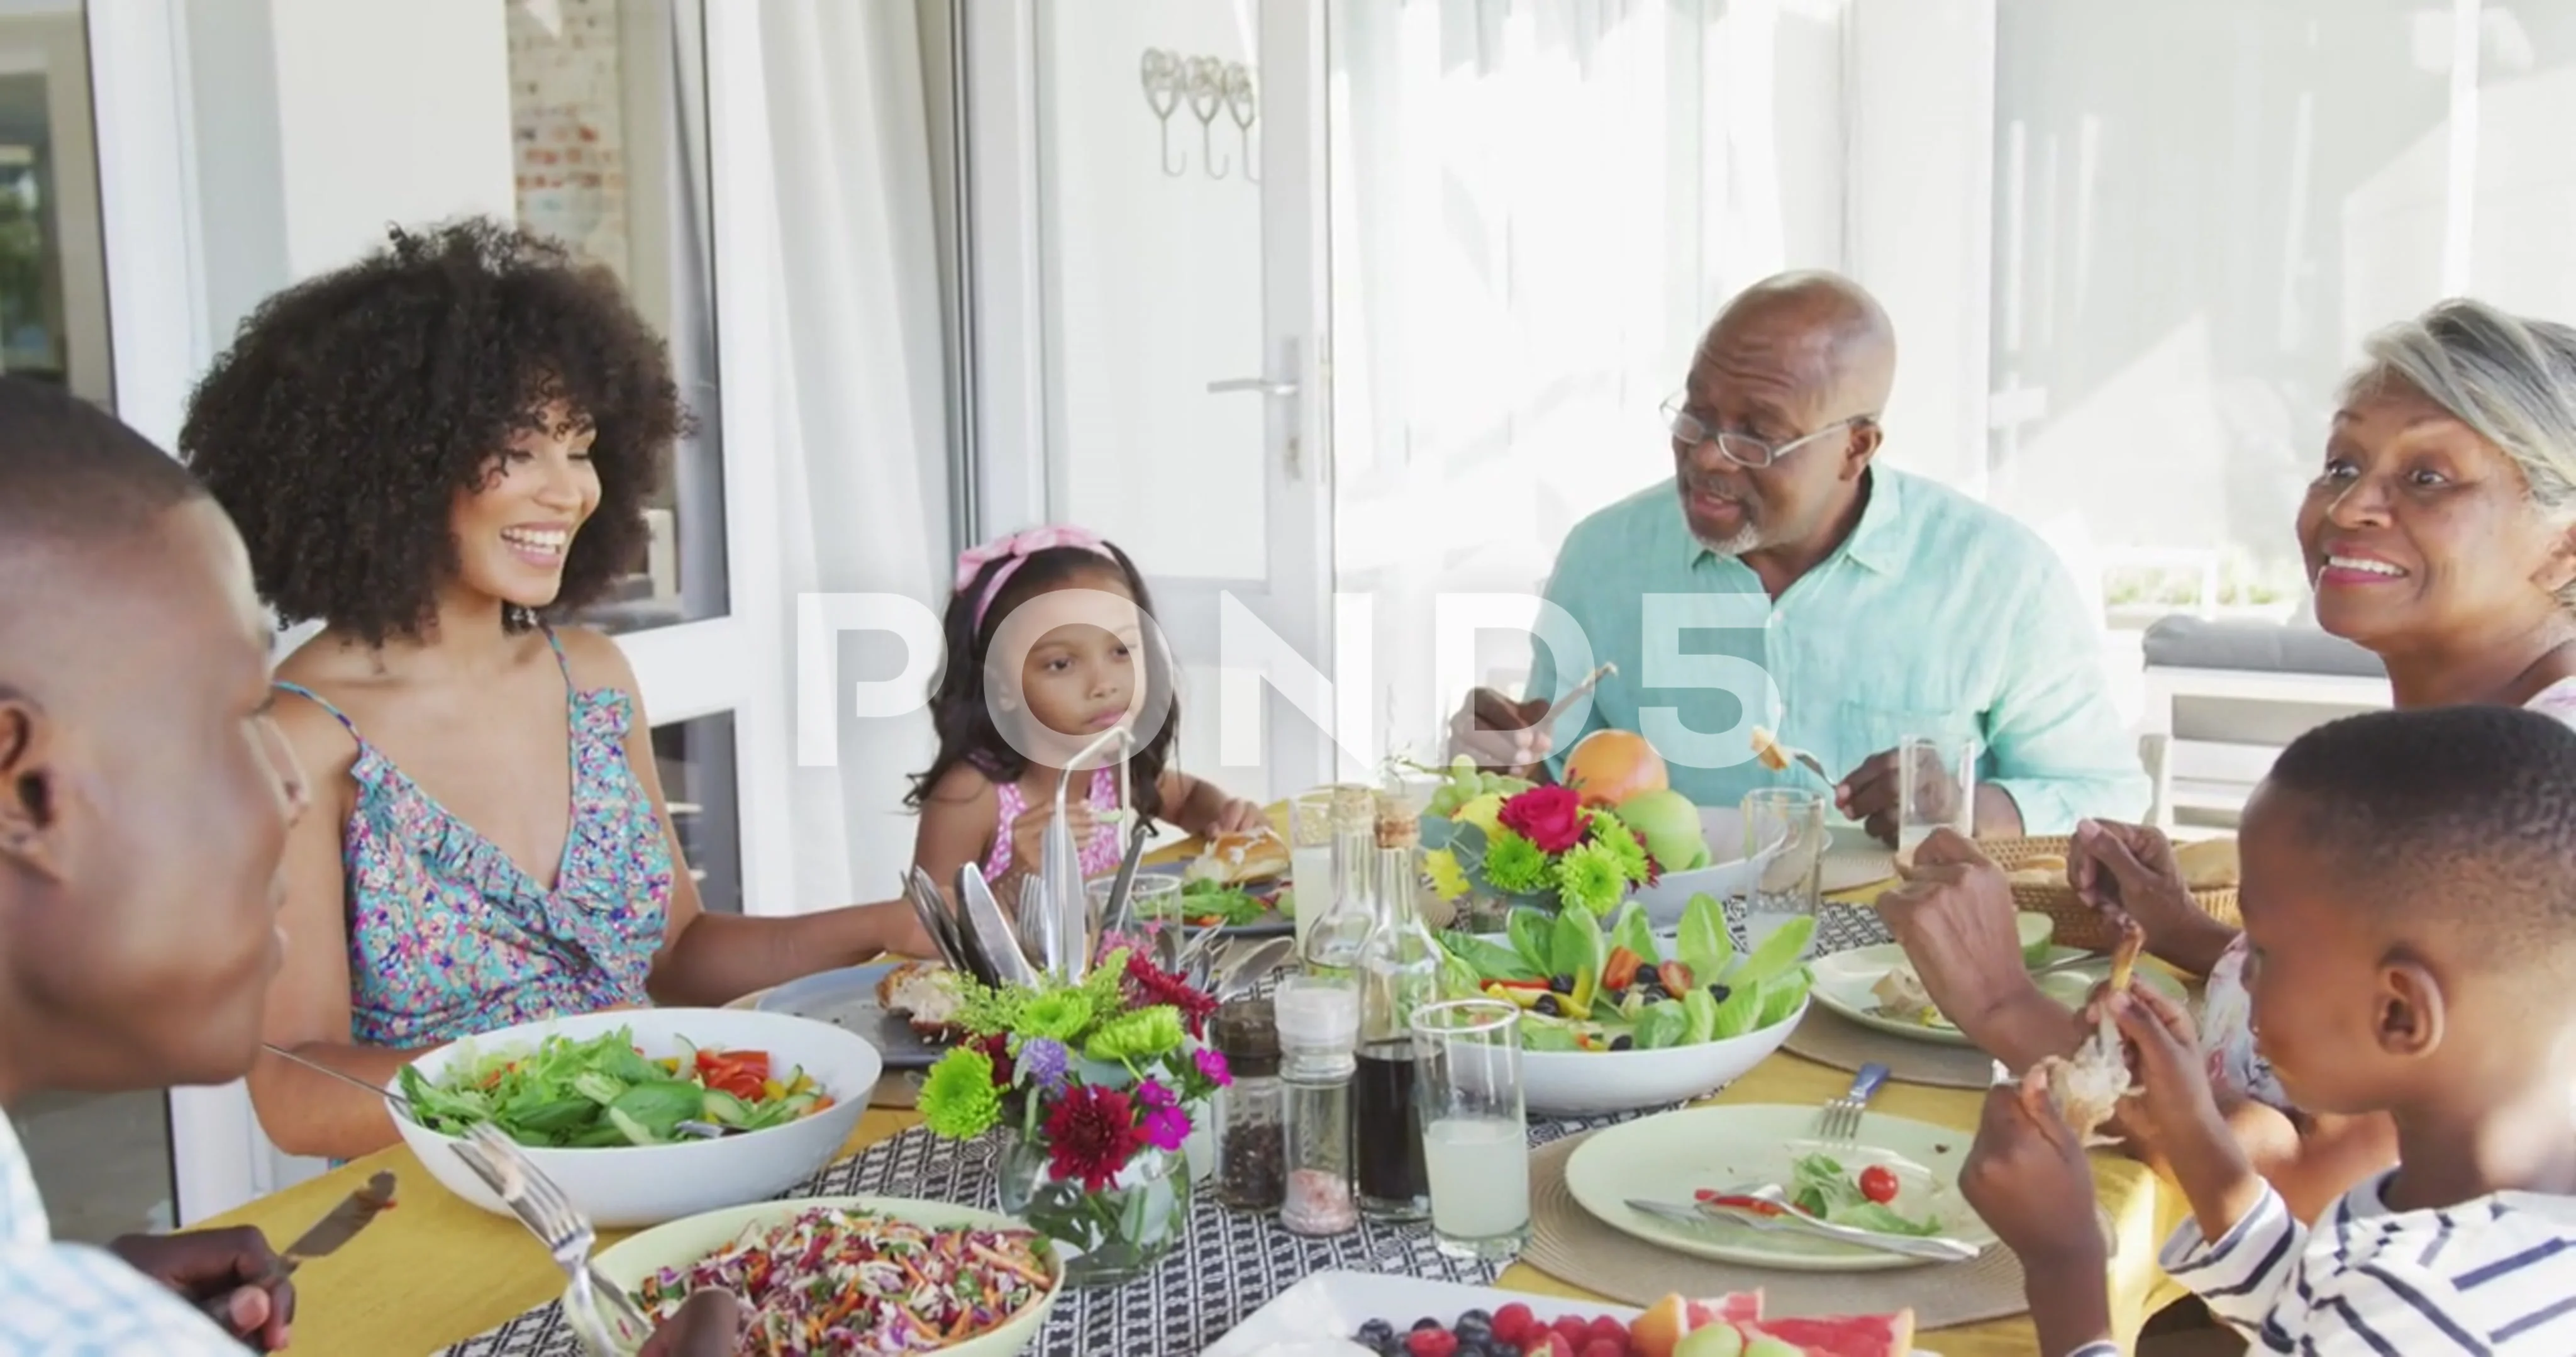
0, 1117, 250, 1357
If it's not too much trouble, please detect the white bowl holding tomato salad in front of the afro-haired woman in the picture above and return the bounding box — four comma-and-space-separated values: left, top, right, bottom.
386, 1009, 884, 1228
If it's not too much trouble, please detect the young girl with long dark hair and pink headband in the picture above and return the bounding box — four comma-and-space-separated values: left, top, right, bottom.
907, 525, 1267, 898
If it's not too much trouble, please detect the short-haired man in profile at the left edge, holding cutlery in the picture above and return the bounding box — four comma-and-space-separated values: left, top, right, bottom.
0, 379, 740, 1357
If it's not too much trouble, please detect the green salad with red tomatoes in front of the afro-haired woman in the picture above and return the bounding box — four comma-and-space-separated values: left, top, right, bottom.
399, 1027, 832, 1148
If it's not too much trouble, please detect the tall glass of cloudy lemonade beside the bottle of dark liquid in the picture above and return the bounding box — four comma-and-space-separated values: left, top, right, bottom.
1414, 999, 1530, 1262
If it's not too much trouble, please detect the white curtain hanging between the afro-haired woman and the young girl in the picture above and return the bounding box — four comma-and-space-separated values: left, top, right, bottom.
752, 0, 950, 909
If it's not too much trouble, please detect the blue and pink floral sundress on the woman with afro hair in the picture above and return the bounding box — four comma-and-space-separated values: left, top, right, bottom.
278, 631, 672, 1048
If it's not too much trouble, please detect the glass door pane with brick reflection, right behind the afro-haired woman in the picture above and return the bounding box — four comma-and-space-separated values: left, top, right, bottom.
505, 0, 726, 631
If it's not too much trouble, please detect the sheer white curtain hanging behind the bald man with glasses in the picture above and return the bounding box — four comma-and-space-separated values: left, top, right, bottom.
1332, 0, 1842, 747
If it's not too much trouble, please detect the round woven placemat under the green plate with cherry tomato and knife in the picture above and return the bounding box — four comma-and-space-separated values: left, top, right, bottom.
1520, 1133, 2030, 1329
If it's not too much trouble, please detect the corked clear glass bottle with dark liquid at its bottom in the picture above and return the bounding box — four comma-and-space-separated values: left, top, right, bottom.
1352, 796, 1440, 1220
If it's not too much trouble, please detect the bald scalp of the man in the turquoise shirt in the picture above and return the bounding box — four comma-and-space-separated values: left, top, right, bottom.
1695, 271, 1896, 420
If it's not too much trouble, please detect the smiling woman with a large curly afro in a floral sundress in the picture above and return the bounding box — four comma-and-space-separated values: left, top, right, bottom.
180, 221, 930, 1159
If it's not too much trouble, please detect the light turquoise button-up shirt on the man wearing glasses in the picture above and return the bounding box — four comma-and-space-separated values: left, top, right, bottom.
1528, 466, 2151, 834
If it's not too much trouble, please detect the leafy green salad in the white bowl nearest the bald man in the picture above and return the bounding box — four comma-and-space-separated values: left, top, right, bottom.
1440, 893, 1816, 1051
